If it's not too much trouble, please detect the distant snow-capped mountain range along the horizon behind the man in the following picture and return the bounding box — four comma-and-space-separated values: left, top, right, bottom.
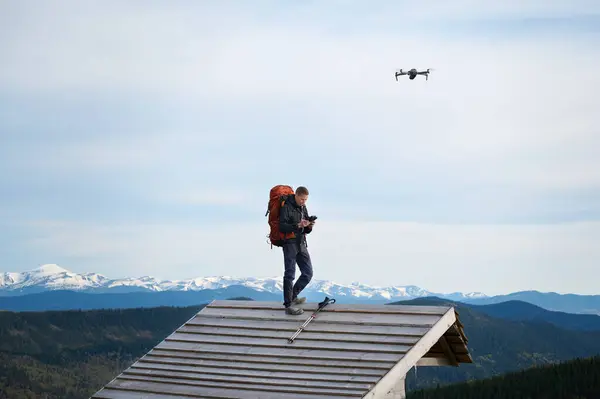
0, 264, 487, 301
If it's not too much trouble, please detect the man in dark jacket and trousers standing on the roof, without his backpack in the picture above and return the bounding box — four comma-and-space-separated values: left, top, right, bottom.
279, 186, 315, 315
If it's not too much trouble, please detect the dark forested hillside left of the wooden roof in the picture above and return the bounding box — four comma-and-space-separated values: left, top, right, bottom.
0, 305, 204, 399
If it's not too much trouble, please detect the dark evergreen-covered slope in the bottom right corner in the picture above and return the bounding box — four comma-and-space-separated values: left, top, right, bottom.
407, 356, 600, 399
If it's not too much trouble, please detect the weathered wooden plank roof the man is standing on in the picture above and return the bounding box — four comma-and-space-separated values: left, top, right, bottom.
91, 300, 472, 399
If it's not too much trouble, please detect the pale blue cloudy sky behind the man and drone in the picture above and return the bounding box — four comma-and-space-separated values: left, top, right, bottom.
0, 0, 600, 295
